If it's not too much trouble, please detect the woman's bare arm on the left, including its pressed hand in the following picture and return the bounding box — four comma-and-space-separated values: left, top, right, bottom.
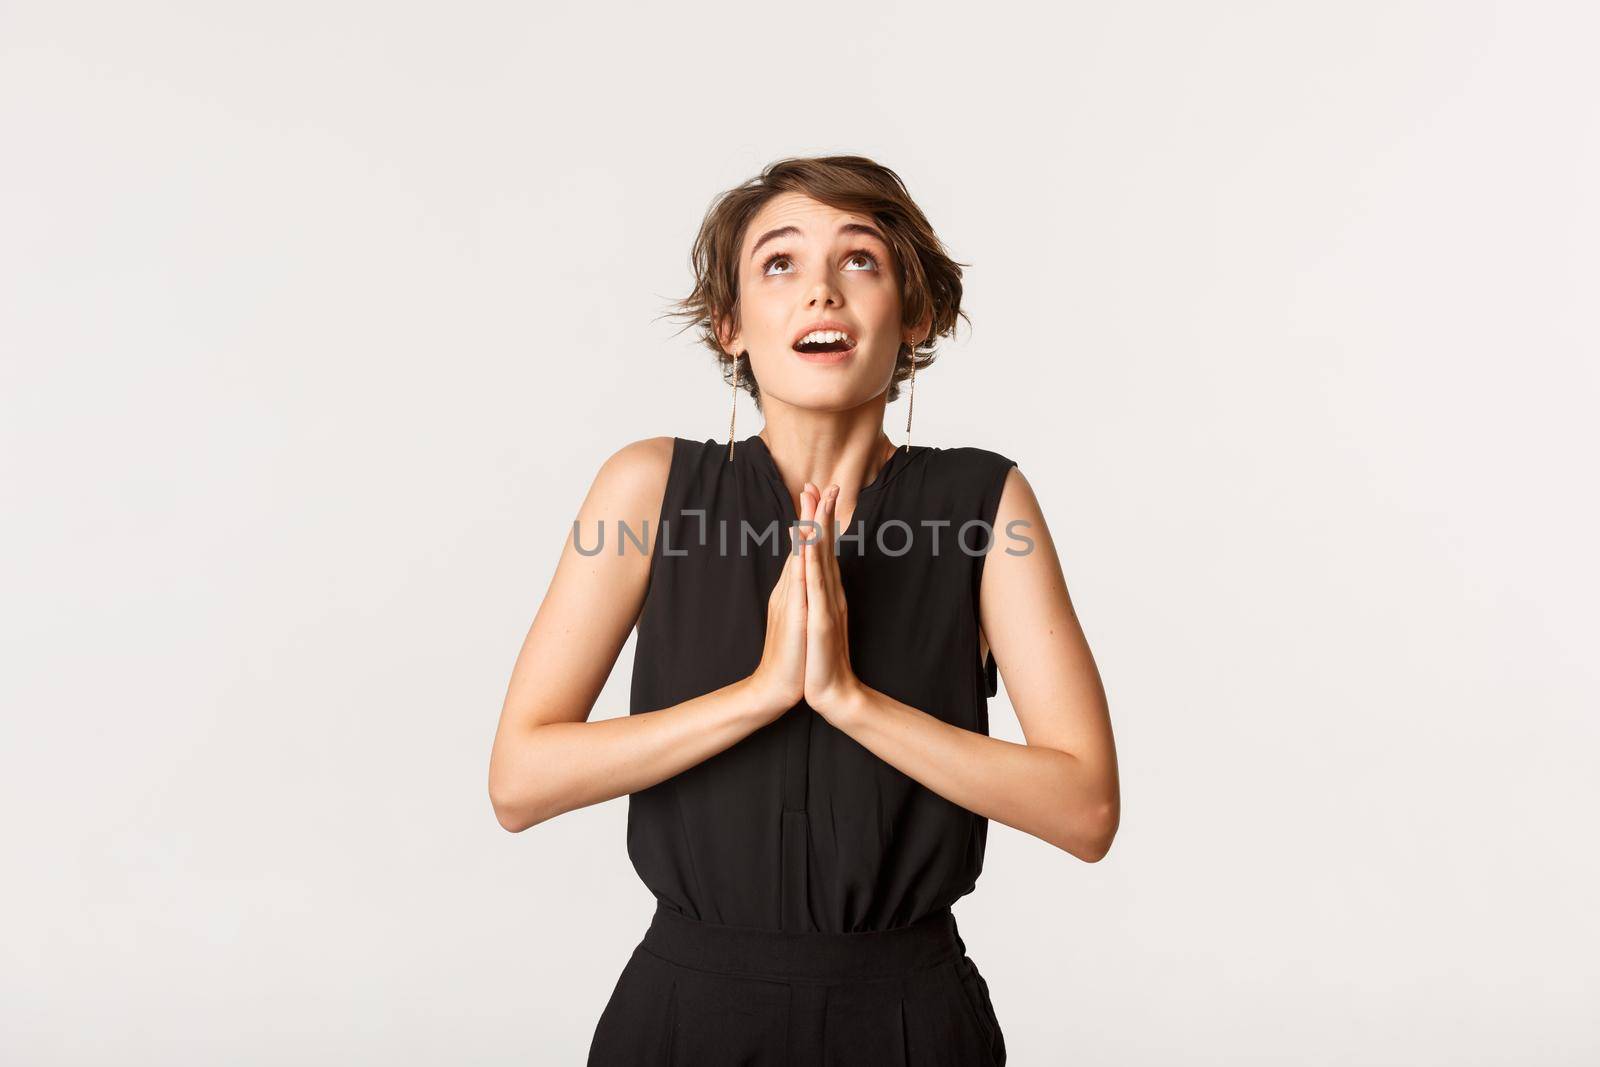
490, 437, 805, 832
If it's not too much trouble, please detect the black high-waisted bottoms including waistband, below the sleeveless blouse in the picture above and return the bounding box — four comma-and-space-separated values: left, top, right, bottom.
589, 902, 1006, 1067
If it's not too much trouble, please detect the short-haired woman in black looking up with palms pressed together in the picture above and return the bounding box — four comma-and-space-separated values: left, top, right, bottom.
490, 157, 1120, 1067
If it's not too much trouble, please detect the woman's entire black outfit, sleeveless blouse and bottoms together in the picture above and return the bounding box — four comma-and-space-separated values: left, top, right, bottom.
590, 435, 1021, 1065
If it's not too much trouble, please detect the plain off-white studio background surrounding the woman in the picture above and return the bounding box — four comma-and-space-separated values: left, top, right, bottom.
0, 0, 1600, 1067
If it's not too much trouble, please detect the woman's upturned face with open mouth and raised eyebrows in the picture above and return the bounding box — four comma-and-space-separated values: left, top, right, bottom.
725, 194, 920, 411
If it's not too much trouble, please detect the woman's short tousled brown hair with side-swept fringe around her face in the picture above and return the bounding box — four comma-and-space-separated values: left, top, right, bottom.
669, 155, 971, 408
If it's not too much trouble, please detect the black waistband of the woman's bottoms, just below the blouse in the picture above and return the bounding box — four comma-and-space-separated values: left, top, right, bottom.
640, 899, 965, 981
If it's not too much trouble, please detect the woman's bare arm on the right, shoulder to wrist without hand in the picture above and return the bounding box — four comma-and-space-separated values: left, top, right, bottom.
829, 467, 1122, 862
